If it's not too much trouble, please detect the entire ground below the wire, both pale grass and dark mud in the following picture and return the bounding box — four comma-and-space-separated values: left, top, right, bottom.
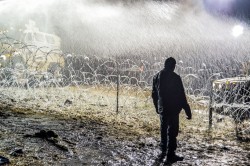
0, 87, 250, 166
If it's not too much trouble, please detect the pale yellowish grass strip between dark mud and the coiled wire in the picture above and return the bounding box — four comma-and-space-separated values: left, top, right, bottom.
2, 86, 248, 143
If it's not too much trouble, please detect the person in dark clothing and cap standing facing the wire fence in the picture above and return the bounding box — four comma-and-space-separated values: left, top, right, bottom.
152, 57, 192, 163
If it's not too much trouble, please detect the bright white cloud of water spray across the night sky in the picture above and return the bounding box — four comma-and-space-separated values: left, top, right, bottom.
0, 0, 250, 57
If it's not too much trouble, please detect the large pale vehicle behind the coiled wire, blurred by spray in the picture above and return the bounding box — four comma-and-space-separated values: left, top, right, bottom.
0, 21, 65, 85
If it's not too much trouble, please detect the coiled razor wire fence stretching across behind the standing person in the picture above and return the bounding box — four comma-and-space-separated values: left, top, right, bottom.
0, 34, 250, 139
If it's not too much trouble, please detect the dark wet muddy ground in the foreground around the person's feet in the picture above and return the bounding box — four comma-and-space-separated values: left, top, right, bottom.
0, 107, 250, 166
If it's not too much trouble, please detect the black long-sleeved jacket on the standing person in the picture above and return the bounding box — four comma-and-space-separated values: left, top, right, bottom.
152, 69, 191, 117
